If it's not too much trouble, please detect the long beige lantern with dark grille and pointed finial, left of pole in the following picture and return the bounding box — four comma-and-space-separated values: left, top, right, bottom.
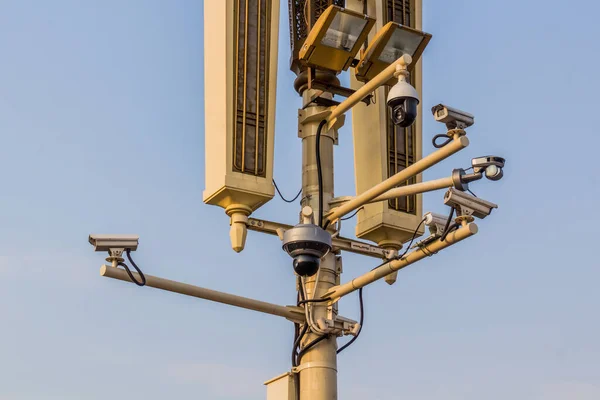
203, 0, 280, 252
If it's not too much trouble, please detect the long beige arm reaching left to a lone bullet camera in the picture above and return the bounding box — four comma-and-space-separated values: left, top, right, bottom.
100, 265, 306, 323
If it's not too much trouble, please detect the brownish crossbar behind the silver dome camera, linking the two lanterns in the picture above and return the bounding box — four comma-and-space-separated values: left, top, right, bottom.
248, 218, 394, 259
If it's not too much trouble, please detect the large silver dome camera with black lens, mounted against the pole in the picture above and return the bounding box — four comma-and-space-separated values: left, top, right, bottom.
283, 224, 331, 276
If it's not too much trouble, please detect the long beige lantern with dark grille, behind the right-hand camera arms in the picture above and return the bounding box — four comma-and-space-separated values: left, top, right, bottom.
346, 0, 426, 268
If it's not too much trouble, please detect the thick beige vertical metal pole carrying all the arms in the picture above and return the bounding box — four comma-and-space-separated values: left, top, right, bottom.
297, 90, 341, 400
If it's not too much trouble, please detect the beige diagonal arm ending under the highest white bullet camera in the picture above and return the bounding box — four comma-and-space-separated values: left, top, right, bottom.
327, 136, 469, 223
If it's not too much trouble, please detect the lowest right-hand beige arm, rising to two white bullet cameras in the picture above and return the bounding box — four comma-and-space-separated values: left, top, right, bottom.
323, 223, 478, 302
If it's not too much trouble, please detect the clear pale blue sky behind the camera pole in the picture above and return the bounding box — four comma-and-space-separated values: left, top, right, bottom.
0, 0, 600, 400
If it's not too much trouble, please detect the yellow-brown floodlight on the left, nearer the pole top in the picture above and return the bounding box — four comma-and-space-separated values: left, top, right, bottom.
299, 5, 375, 72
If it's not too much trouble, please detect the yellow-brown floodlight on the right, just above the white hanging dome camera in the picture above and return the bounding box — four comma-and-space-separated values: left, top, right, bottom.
356, 22, 431, 85
